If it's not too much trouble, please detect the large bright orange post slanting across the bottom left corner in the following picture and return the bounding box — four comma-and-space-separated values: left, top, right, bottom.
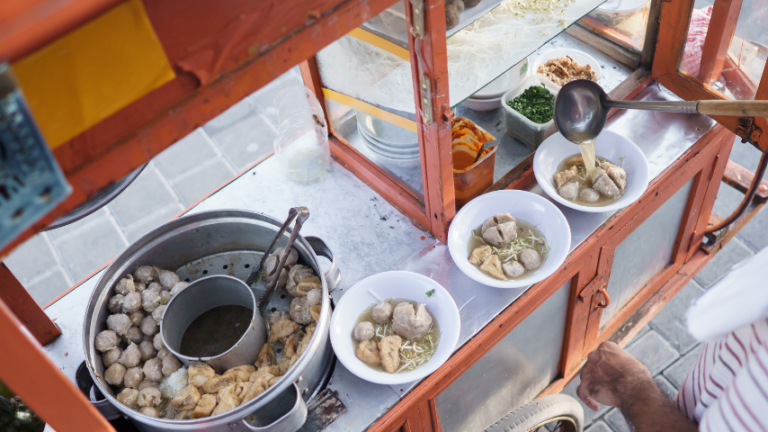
0, 300, 114, 432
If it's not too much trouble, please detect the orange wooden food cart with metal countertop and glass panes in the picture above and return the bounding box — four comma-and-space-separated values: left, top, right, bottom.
0, 0, 768, 432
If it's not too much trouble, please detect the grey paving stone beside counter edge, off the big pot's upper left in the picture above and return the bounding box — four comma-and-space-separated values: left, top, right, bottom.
53, 212, 128, 282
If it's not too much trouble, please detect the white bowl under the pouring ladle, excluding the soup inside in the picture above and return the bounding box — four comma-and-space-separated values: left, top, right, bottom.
533, 130, 650, 213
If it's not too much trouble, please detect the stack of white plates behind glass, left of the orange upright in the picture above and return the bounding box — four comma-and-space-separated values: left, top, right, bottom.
356, 111, 420, 166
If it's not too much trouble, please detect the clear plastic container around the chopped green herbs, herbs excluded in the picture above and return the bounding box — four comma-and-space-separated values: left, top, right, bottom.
501, 75, 560, 151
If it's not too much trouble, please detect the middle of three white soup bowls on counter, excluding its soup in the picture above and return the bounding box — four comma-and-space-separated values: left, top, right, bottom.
448, 190, 571, 288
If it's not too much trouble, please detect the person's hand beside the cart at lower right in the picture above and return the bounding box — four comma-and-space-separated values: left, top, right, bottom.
576, 342, 655, 411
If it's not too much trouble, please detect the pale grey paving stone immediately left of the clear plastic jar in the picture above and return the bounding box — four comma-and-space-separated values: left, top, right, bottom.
212, 115, 277, 171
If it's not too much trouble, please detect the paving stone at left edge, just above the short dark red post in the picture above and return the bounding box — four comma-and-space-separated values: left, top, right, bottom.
3, 234, 59, 286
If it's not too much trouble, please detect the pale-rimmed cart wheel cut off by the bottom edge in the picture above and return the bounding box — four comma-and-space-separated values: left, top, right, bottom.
485, 394, 584, 432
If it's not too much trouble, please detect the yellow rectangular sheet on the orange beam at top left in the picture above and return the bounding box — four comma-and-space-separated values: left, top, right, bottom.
12, 0, 175, 149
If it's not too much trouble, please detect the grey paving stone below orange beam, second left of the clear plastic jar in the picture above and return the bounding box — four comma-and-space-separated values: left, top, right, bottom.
154, 129, 219, 180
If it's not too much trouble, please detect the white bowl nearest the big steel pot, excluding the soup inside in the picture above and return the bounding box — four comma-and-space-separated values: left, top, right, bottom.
331, 271, 461, 385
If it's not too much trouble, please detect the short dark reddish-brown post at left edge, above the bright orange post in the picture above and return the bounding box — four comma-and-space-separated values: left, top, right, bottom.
0, 262, 61, 349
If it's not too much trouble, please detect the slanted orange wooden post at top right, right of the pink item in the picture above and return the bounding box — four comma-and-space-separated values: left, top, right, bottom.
699, 0, 742, 84
